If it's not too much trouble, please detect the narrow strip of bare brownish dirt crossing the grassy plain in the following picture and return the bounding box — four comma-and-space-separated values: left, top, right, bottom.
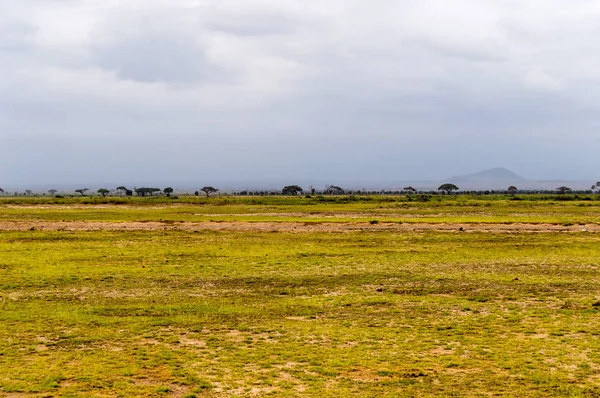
0, 221, 600, 233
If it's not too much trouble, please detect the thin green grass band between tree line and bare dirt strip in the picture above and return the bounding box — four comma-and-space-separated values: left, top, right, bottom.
0, 195, 600, 225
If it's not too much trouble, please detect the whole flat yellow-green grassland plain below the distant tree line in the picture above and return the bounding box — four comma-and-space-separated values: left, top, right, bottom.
0, 196, 600, 397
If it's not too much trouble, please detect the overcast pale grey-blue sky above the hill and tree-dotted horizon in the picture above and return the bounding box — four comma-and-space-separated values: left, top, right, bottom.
0, 0, 600, 186
